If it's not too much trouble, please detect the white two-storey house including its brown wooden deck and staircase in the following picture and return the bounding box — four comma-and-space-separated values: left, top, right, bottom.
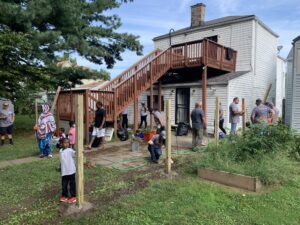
58, 3, 280, 138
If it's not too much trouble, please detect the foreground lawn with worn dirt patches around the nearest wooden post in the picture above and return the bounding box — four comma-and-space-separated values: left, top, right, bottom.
0, 154, 300, 225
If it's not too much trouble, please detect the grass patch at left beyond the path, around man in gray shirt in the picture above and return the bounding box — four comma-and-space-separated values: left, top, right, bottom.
0, 115, 39, 161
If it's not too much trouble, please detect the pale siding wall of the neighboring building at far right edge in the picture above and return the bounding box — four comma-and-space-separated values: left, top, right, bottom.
292, 41, 300, 132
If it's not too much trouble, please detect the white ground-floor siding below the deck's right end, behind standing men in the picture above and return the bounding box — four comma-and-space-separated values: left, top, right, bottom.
227, 72, 254, 127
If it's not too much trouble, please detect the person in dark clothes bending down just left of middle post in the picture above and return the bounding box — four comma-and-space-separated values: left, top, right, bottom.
148, 132, 165, 163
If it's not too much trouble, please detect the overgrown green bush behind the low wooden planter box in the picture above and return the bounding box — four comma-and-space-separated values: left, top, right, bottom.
181, 124, 300, 185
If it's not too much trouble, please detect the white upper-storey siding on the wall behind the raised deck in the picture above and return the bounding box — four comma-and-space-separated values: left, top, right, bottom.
154, 20, 254, 71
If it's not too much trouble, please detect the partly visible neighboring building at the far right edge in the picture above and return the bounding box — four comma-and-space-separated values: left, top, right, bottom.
285, 36, 300, 132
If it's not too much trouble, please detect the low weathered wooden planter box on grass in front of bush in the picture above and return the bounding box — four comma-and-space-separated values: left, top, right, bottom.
198, 168, 262, 192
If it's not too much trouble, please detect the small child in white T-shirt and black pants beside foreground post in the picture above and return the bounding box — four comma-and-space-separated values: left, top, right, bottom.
59, 138, 76, 203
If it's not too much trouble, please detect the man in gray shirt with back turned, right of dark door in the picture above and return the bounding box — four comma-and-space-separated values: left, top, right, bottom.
191, 102, 206, 148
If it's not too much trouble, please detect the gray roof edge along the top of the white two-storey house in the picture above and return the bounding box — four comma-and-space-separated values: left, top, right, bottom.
153, 15, 279, 41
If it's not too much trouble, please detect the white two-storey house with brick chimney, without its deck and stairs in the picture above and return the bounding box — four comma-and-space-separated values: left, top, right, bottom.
129, 4, 281, 127
